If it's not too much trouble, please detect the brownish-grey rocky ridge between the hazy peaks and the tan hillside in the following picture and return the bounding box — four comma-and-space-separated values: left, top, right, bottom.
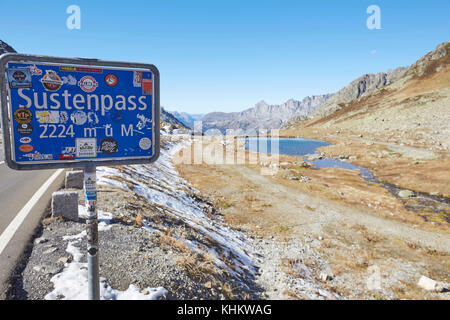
284, 67, 409, 128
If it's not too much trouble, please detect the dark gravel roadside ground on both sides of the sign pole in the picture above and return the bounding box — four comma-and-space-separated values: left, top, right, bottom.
8, 192, 263, 300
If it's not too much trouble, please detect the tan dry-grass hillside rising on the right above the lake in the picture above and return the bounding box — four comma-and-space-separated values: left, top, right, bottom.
286, 42, 450, 151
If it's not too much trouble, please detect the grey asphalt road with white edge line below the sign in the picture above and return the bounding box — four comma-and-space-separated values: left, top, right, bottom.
0, 143, 64, 299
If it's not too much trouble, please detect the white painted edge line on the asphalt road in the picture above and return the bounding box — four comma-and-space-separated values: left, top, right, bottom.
0, 169, 64, 255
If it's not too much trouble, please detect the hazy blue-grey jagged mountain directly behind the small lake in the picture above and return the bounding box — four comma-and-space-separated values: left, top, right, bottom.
201, 94, 332, 134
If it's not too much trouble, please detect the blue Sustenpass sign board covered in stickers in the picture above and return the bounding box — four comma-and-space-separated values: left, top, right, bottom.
0, 54, 159, 169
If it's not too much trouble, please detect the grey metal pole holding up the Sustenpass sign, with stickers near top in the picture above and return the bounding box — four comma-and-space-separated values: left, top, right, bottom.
84, 165, 100, 300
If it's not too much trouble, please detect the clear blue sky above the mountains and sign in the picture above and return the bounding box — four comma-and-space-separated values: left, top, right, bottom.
0, 0, 450, 113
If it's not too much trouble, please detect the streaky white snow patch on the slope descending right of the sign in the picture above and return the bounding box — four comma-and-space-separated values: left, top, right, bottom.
97, 144, 255, 275
